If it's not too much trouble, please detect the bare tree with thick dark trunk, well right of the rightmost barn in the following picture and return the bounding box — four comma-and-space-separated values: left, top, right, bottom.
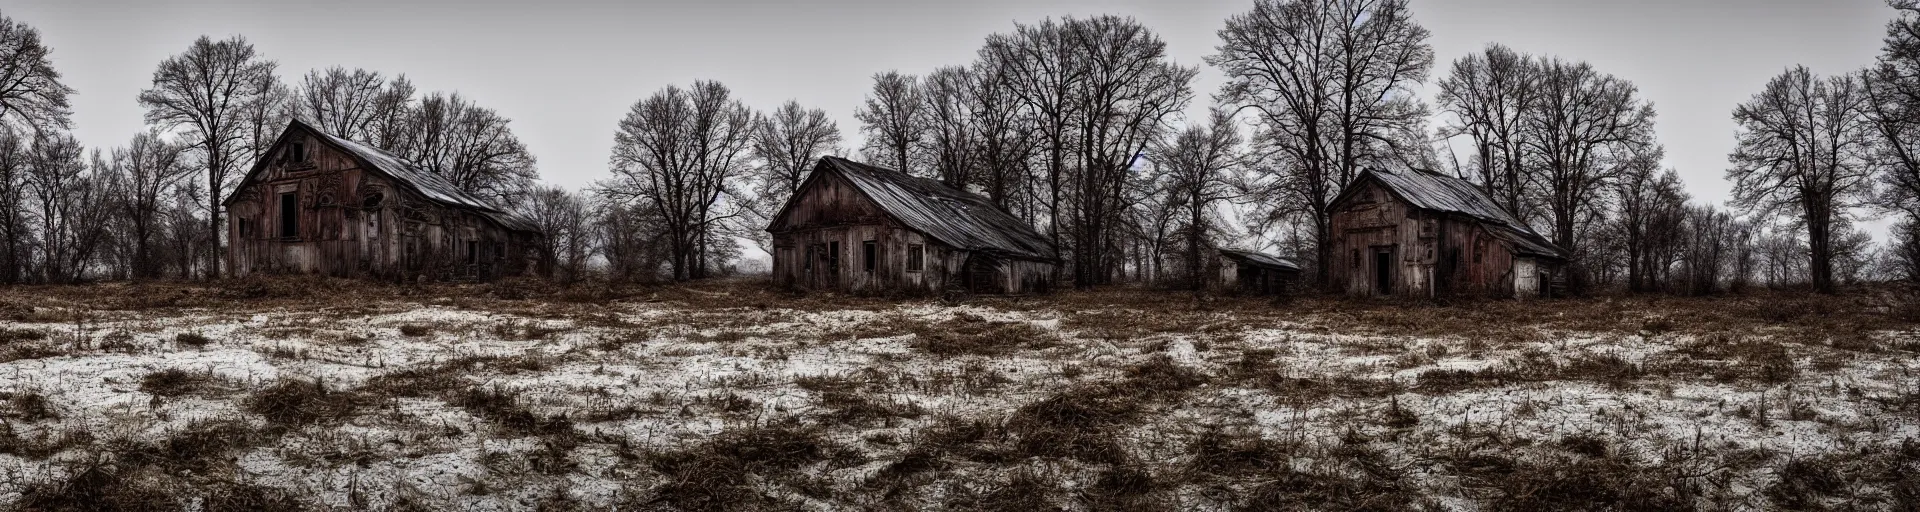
1726, 67, 1874, 291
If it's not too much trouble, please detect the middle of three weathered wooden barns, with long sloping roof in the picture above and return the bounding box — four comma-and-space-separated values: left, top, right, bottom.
766, 157, 1058, 293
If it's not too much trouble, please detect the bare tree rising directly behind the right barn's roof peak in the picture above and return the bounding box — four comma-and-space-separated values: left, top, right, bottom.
1436, 44, 1538, 221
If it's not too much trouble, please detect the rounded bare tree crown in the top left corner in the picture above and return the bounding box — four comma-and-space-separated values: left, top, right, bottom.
0, 15, 73, 130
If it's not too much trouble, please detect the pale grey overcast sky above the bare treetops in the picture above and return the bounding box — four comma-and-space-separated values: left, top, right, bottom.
0, 0, 1893, 210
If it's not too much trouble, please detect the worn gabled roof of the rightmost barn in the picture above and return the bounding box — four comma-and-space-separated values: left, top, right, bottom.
1332, 169, 1567, 259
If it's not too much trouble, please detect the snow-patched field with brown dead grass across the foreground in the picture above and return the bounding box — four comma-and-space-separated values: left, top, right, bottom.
0, 287, 1920, 510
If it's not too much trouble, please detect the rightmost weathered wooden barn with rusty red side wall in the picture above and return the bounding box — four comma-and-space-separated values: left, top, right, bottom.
1327, 169, 1567, 297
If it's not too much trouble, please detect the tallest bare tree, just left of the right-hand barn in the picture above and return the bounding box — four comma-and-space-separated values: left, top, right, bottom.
1208, 0, 1432, 284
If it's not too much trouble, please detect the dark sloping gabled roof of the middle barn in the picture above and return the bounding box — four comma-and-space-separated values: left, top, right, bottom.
770, 157, 1056, 261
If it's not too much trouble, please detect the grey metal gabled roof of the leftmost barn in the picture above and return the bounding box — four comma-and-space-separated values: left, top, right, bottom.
223, 119, 540, 232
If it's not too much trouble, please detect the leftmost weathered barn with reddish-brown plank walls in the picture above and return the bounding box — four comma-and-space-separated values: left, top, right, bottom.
225, 121, 541, 280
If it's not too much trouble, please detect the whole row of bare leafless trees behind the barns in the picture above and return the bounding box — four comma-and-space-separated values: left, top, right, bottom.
0, 0, 1920, 293
